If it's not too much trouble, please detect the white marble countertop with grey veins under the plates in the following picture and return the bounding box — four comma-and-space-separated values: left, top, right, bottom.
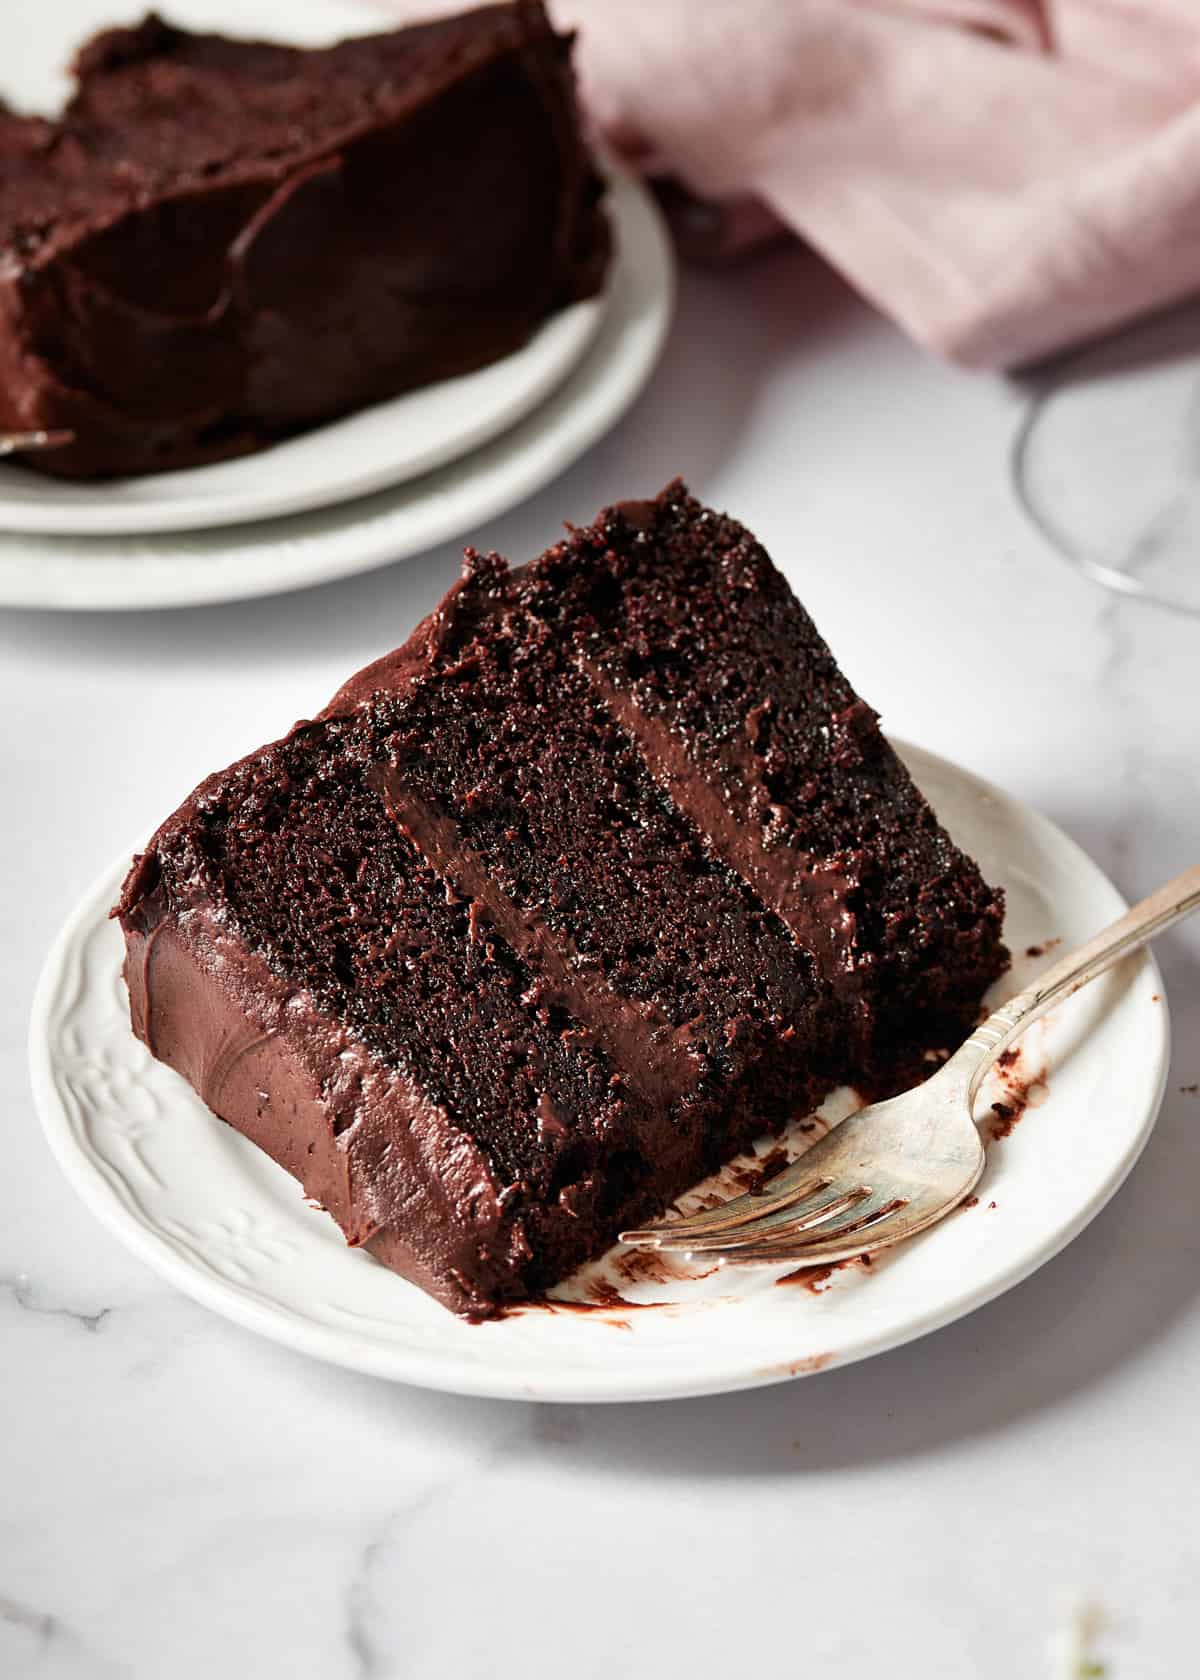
0, 250, 1200, 1680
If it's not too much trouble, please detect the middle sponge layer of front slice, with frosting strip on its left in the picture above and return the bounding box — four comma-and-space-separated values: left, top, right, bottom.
359, 603, 839, 1124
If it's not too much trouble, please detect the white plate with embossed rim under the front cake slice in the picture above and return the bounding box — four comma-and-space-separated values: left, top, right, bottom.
30, 748, 1168, 1401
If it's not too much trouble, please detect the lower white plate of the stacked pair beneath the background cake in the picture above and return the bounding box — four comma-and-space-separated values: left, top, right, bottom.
0, 170, 674, 610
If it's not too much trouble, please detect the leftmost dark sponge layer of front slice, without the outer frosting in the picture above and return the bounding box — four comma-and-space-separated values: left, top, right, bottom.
148, 727, 655, 1198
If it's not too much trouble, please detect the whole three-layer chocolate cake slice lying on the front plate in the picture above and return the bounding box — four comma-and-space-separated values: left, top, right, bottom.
119, 484, 1005, 1317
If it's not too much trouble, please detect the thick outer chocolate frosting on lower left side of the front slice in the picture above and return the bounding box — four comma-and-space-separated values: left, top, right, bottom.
123, 885, 528, 1315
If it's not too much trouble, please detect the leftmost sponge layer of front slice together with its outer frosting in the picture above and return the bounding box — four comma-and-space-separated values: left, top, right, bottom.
117, 752, 701, 1314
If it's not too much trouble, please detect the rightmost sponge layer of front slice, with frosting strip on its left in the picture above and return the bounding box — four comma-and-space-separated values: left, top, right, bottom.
523, 484, 1002, 1052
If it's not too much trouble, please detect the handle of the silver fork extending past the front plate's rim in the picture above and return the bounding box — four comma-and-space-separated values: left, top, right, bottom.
946, 864, 1200, 1102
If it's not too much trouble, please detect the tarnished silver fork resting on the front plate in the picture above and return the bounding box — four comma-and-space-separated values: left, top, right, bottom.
620, 865, 1200, 1265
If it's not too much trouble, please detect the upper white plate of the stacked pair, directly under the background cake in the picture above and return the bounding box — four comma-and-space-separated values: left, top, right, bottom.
0, 292, 607, 536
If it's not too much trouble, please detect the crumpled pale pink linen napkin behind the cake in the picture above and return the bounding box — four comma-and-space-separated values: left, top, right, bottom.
363, 0, 1200, 366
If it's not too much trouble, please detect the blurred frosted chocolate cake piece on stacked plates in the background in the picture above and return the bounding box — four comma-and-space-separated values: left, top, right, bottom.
0, 0, 608, 477
